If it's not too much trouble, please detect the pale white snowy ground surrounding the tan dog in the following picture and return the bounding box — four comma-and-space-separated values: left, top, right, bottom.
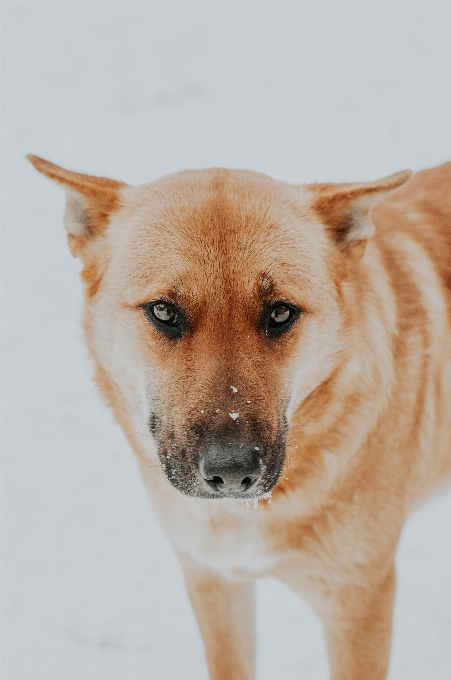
2, 1, 451, 680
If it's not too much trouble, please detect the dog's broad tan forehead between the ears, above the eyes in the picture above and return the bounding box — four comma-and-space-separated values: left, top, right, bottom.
111, 169, 327, 302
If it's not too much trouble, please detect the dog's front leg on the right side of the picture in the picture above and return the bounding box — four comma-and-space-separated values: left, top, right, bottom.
323, 566, 395, 680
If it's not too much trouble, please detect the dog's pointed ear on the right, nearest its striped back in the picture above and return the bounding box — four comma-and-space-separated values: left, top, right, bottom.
307, 170, 412, 254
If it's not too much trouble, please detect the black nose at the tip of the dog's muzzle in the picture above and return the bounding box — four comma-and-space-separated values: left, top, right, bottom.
199, 443, 263, 496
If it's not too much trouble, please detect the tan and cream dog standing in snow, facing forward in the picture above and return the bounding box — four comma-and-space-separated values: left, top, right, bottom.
28, 156, 451, 680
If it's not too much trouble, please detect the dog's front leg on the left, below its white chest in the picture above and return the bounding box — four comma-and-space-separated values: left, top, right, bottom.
179, 554, 255, 680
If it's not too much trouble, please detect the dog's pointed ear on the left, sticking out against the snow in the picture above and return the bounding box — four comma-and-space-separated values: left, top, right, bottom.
27, 155, 127, 259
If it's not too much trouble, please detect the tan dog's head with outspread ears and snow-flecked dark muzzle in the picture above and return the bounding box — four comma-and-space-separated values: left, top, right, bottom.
29, 157, 409, 498
